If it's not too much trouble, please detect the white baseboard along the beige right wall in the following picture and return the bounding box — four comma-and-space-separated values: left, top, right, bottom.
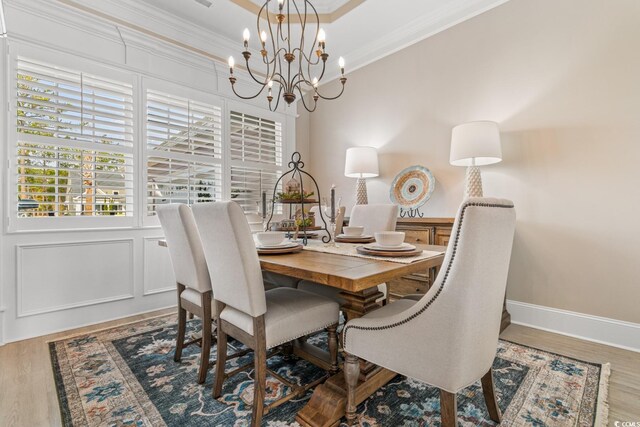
507, 300, 640, 352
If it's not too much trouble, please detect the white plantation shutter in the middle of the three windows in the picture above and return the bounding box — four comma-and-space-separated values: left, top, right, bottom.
146, 90, 222, 215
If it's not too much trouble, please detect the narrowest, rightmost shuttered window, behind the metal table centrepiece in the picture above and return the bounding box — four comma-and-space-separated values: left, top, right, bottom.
229, 111, 282, 212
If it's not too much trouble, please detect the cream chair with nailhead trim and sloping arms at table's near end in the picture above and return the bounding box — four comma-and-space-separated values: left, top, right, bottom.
343, 198, 515, 427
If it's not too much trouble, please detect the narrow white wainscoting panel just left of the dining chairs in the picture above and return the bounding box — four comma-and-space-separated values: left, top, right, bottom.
144, 237, 176, 296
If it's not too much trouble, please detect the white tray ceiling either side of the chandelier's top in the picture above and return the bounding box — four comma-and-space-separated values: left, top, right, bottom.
52, 0, 508, 81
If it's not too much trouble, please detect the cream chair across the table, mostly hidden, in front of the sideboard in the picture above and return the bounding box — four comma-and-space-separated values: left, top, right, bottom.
298, 204, 398, 304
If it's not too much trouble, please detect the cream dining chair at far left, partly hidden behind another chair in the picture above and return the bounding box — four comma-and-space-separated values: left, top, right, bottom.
157, 203, 215, 384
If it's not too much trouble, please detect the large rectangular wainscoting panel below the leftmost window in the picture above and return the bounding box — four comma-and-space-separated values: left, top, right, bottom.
16, 239, 134, 317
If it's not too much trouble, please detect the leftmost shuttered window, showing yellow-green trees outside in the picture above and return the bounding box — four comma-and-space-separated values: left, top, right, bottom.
15, 58, 134, 217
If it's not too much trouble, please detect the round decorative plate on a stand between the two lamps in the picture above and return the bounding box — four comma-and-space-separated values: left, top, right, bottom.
389, 166, 436, 218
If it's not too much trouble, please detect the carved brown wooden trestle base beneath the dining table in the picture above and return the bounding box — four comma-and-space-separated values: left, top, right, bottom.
296, 287, 397, 427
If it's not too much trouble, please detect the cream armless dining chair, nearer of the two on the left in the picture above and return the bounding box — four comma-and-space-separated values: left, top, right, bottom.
193, 202, 339, 426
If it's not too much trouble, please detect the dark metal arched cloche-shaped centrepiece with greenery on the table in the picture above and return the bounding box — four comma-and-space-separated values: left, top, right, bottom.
267, 151, 331, 245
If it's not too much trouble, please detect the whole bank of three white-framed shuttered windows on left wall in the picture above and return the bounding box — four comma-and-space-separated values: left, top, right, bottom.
8, 52, 291, 232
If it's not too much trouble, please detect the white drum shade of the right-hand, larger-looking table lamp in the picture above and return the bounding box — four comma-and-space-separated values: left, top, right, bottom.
449, 121, 502, 166
